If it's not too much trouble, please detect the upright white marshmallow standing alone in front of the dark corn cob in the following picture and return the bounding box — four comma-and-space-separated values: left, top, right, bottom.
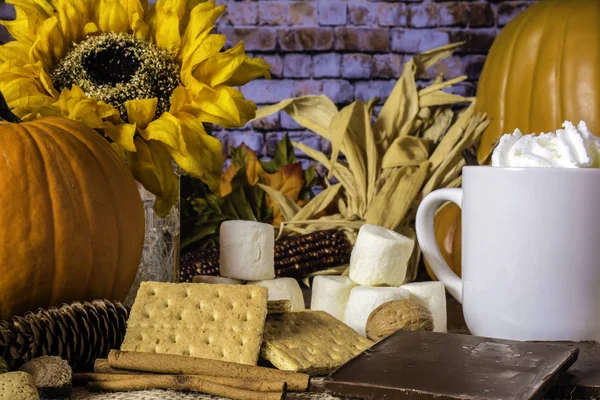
219, 221, 275, 281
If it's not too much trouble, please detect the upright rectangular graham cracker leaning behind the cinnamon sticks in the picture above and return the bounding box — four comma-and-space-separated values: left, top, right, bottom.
121, 282, 267, 365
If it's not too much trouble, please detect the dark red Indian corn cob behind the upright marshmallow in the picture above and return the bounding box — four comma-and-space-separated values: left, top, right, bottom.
179, 229, 352, 282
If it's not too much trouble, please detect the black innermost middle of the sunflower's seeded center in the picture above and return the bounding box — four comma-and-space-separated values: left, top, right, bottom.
82, 45, 142, 86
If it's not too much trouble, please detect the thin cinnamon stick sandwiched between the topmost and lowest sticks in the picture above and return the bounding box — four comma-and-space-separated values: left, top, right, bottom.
73, 372, 285, 392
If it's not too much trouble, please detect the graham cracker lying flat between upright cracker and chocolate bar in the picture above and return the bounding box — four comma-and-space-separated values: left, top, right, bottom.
260, 310, 373, 375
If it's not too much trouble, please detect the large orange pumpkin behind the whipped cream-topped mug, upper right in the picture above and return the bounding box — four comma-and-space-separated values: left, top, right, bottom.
477, 0, 600, 162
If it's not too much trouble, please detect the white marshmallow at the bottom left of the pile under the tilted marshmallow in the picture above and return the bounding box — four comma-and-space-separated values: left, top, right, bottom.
310, 275, 356, 321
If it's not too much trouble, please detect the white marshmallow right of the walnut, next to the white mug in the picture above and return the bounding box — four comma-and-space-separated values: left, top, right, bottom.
400, 282, 448, 333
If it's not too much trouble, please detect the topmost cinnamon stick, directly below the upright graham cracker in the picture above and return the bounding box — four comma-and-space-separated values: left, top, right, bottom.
108, 350, 310, 392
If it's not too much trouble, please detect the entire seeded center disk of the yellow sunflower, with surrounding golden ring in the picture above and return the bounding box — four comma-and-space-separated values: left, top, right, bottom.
51, 33, 179, 122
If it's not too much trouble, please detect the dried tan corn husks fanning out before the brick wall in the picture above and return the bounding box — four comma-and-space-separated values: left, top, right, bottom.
251, 43, 489, 280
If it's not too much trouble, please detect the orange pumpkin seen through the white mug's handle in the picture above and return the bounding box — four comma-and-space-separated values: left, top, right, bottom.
425, 203, 462, 281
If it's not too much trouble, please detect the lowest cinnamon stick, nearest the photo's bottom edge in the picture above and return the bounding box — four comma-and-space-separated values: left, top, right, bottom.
87, 375, 285, 400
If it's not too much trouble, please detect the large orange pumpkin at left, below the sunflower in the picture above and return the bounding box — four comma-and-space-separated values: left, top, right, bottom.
0, 102, 144, 319
